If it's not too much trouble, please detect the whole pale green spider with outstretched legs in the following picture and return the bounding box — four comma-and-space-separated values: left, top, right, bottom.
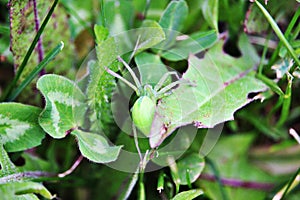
105, 56, 183, 137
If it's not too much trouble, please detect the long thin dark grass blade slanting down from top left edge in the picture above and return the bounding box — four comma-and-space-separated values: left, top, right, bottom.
1, 0, 58, 100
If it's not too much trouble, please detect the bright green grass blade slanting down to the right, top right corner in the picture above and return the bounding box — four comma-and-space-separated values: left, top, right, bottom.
255, 1, 300, 72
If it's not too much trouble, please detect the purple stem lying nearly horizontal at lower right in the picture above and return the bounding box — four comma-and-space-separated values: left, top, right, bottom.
200, 174, 274, 191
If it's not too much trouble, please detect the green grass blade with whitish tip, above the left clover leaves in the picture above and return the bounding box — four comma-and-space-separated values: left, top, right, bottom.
7, 42, 64, 101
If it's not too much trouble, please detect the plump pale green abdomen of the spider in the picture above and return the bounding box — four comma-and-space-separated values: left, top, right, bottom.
132, 96, 156, 136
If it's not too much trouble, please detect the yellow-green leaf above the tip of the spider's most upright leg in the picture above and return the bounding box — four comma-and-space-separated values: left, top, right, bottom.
136, 20, 166, 52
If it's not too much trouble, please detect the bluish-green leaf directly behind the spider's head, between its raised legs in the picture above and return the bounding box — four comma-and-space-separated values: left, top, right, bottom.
134, 52, 168, 85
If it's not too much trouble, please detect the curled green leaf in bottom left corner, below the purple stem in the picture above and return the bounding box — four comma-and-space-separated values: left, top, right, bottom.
0, 182, 53, 200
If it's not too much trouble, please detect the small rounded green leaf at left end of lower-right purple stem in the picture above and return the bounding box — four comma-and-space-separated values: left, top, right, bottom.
172, 153, 205, 185
